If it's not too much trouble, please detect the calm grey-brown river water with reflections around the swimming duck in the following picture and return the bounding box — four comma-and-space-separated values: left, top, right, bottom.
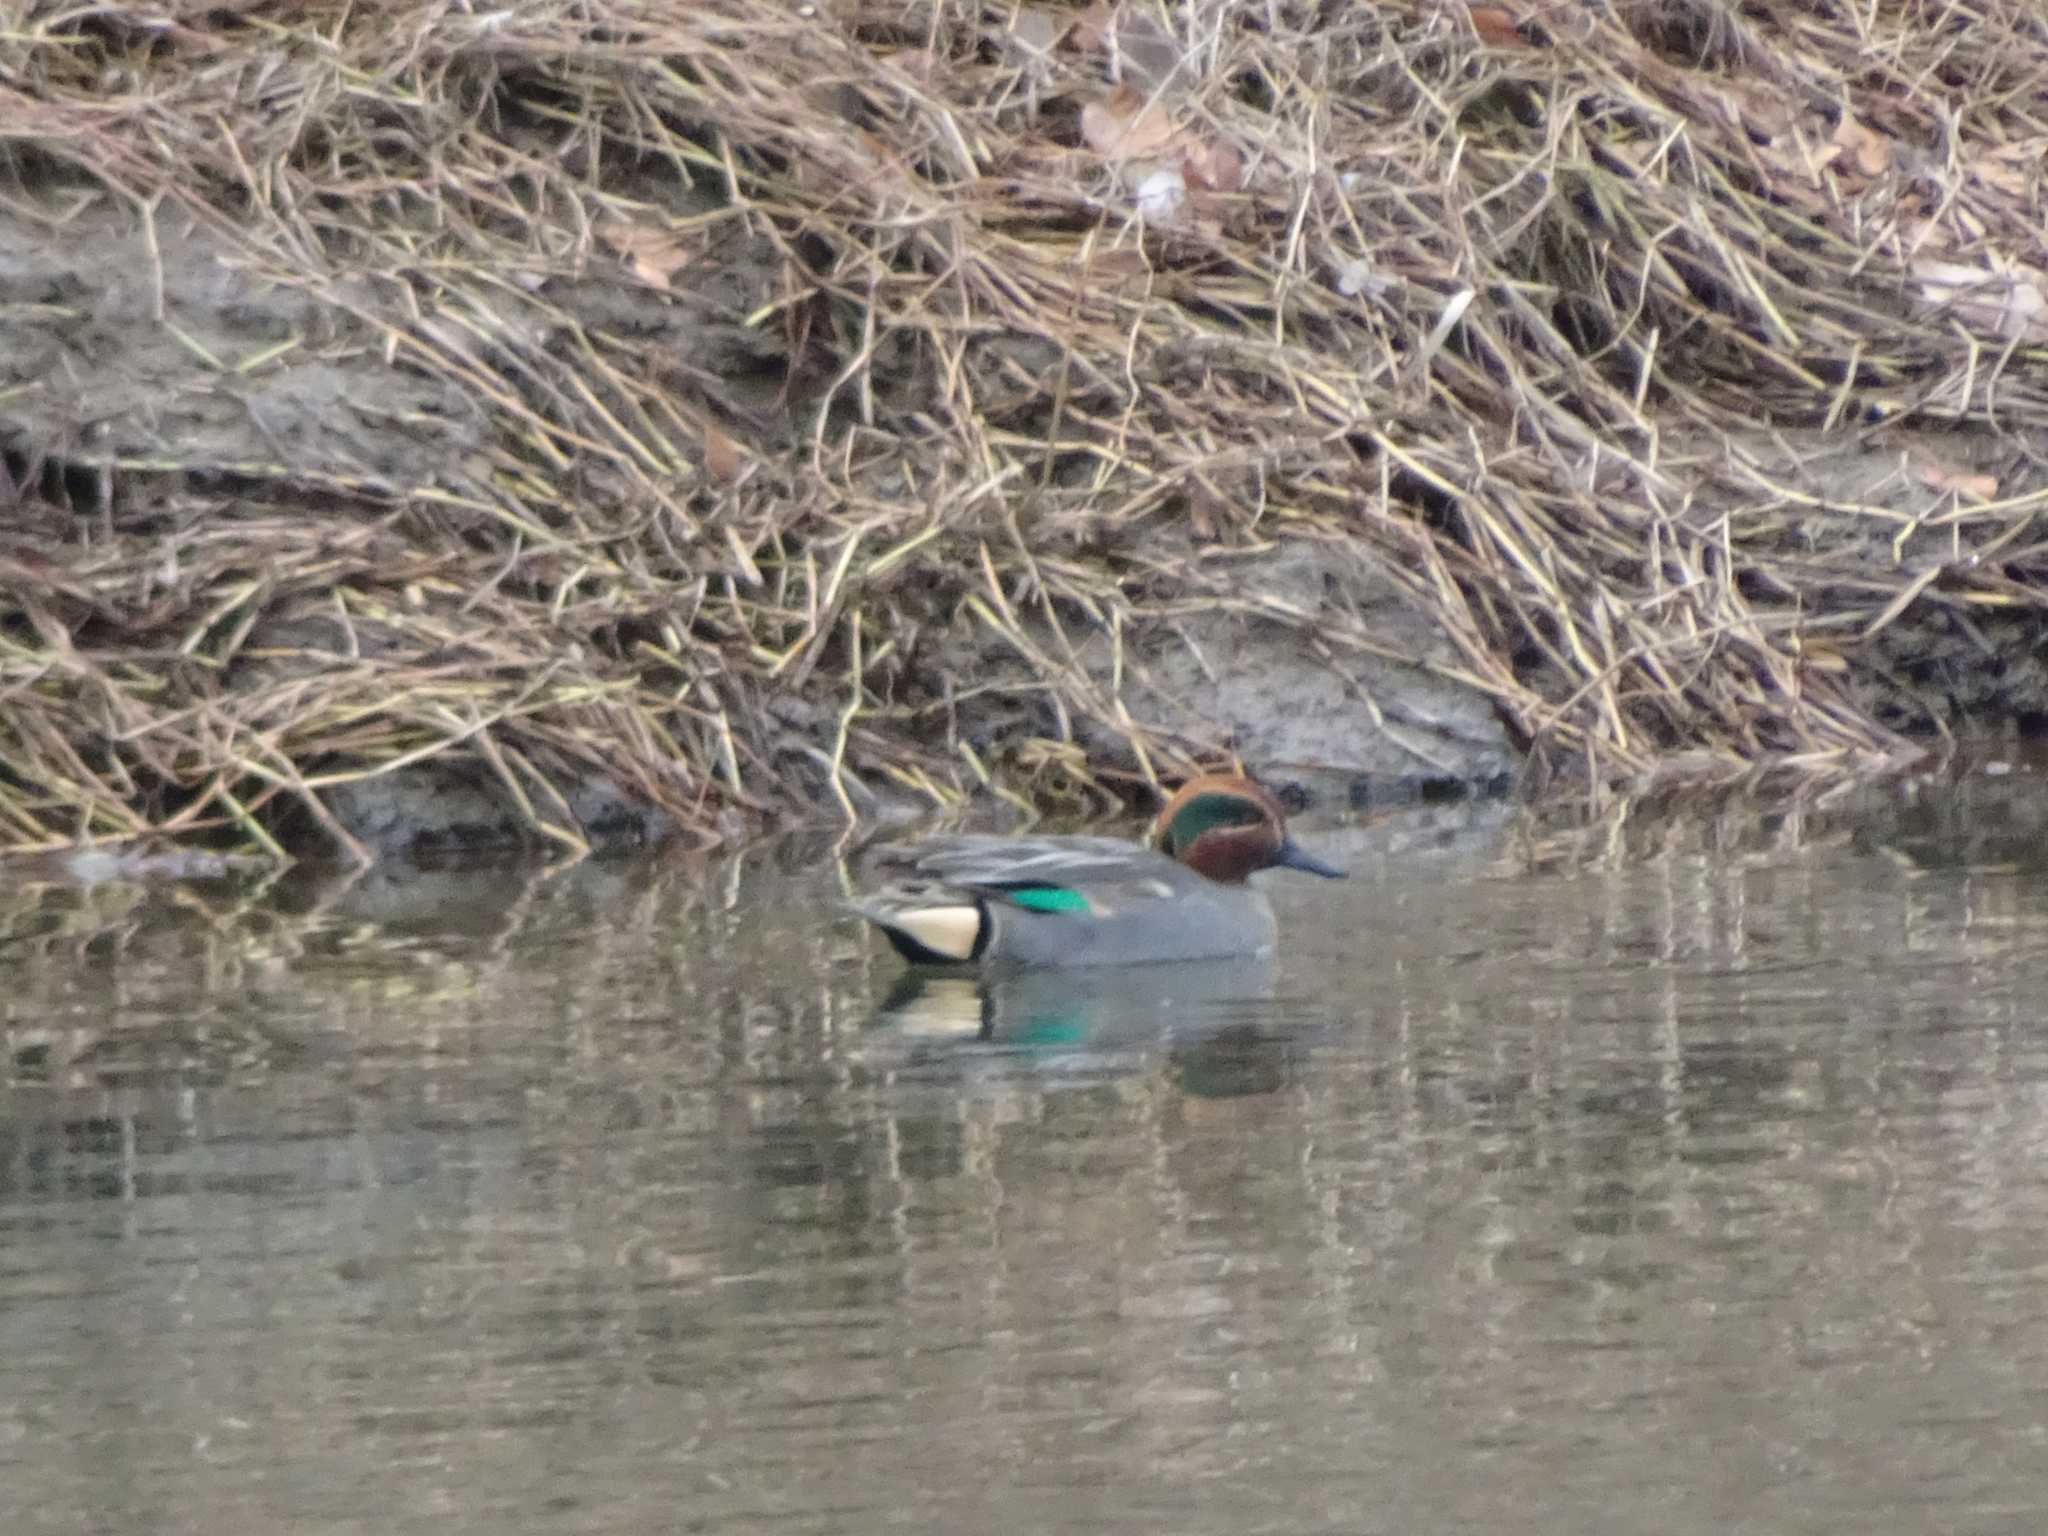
0, 782, 2048, 1536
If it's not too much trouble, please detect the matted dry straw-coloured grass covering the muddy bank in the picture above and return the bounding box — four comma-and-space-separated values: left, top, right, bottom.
0, 0, 2048, 848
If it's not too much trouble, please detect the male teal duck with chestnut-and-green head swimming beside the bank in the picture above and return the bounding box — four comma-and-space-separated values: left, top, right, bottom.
854, 774, 1343, 969
